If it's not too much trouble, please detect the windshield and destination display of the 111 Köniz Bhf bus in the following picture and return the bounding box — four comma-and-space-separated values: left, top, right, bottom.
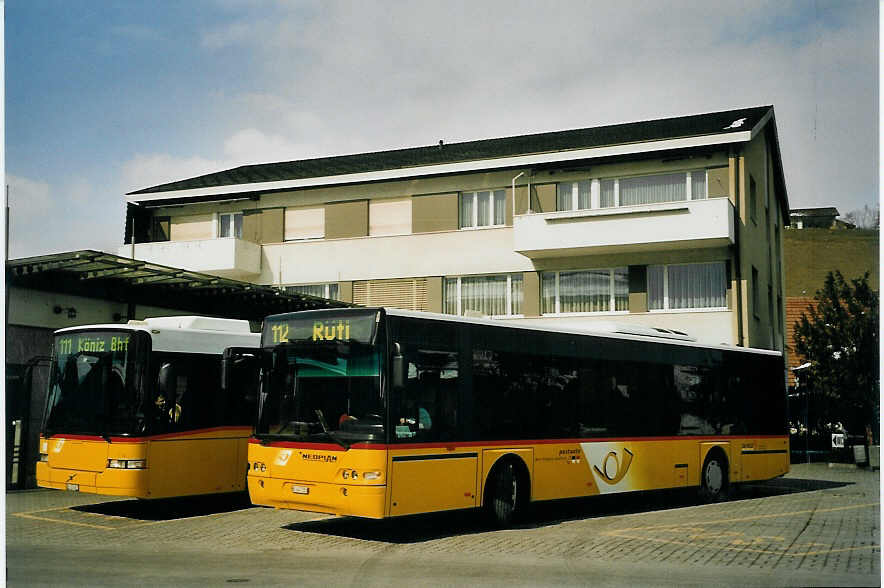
43, 331, 148, 437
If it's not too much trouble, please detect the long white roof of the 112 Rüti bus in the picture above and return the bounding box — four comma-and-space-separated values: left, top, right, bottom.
268, 307, 783, 356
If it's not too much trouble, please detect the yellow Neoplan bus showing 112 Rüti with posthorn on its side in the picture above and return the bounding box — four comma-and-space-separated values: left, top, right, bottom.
248, 308, 789, 525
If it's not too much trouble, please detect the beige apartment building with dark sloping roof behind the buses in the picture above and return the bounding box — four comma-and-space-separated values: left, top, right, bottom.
120, 106, 789, 350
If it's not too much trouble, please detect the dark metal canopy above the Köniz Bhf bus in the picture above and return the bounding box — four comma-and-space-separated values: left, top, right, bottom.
6, 249, 352, 321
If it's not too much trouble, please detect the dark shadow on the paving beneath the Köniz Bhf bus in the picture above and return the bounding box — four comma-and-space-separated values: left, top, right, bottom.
71, 492, 252, 521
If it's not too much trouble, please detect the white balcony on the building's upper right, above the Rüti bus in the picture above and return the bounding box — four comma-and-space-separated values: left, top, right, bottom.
513, 198, 734, 259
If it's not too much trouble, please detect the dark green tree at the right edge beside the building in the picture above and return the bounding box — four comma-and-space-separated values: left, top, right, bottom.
794, 271, 880, 435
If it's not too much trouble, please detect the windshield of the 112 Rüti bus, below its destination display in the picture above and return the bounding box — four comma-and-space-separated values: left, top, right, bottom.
256, 341, 385, 448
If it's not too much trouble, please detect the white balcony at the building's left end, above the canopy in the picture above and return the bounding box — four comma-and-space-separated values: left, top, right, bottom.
119, 238, 261, 280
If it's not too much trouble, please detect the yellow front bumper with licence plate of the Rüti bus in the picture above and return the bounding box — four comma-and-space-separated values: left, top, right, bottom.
248, 475, 387, 519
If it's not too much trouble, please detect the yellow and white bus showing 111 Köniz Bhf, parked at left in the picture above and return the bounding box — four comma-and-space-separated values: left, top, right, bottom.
37, 316, 260, 499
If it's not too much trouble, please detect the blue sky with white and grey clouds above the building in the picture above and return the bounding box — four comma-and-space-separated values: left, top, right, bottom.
5, 0, 879, 258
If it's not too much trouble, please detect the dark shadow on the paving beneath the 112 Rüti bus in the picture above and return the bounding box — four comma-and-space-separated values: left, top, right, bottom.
283, 478, 851, 544
